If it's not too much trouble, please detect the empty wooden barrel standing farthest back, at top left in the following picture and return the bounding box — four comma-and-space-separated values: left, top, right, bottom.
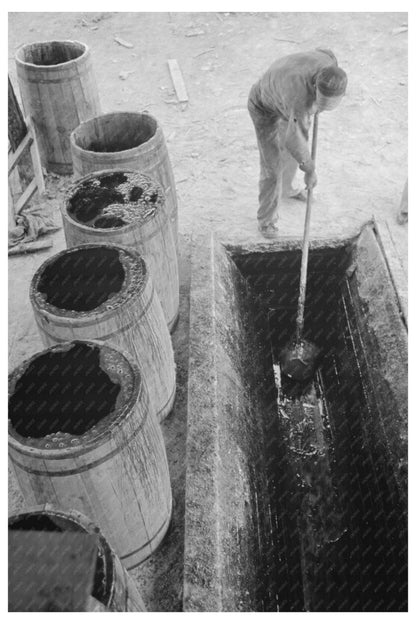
16, 41, 101, 174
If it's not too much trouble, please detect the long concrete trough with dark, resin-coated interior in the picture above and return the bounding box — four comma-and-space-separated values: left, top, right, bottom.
184, 224, 407, 611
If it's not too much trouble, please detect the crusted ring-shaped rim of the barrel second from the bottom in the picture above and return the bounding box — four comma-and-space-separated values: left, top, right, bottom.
8, 339, 146, 461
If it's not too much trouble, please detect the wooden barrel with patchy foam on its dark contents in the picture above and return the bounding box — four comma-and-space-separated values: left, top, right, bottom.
62, 169, 179, 331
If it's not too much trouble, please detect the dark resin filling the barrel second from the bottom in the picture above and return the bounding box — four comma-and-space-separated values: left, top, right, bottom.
9, 343, 120, 439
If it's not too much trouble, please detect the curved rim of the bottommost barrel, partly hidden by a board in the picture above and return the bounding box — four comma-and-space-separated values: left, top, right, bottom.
8, 503, 116, 606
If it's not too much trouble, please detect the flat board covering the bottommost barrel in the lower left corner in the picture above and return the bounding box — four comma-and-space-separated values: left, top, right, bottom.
9, 530, 97, 612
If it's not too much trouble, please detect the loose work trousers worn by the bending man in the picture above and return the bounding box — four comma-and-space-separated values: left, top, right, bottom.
248, 93, 299, 228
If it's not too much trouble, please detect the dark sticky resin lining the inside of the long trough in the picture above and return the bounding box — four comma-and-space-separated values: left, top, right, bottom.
233, 247, 407, 611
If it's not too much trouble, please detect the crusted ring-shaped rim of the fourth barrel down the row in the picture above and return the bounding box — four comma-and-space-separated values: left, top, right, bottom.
29, 241, 150, 325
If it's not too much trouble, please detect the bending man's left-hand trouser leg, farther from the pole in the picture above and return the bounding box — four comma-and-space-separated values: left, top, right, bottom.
249, 109, 283, 228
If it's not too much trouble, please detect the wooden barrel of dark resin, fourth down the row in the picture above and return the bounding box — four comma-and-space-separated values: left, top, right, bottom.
30, 243, 176, 420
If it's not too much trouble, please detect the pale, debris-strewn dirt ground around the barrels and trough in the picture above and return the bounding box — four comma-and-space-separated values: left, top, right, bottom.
9, 12, 408, 611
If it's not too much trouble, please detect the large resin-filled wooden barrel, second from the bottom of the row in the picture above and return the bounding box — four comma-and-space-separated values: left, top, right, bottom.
9, 341, 172, 569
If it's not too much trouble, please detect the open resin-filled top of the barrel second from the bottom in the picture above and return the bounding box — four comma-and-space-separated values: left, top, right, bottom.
9, 340, 142, 450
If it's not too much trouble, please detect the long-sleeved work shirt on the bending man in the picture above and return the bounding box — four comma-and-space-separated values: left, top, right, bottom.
250, 48, 338, 163
